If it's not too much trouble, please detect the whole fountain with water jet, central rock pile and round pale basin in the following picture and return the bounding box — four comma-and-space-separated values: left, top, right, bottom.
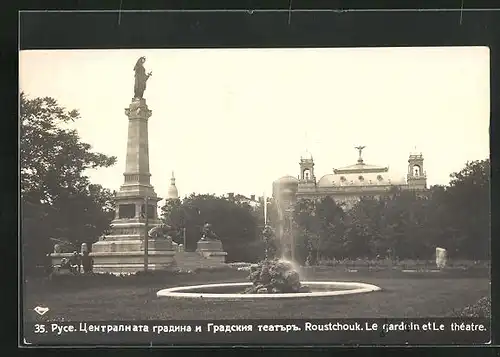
157, 196, 381, 300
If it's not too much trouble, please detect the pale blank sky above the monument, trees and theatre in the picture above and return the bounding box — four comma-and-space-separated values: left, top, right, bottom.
20, 47, 490, 197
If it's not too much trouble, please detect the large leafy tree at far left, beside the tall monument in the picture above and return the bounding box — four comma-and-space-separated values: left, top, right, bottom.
20, 93, 116, 268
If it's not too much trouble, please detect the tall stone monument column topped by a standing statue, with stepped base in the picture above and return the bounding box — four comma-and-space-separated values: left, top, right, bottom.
92, 57, 175, 273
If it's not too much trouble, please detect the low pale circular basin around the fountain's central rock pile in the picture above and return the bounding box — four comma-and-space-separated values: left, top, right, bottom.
156, 281, 381, 300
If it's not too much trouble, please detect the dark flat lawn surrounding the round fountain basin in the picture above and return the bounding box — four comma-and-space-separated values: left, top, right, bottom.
23, 267, 490, 321
